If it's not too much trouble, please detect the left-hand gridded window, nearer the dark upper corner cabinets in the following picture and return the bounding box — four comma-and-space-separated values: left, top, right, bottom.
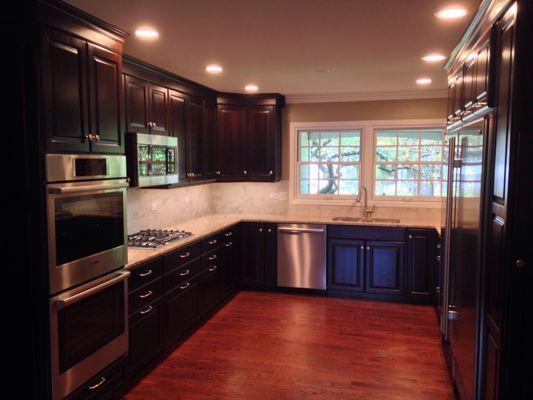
296, 130, 361, 198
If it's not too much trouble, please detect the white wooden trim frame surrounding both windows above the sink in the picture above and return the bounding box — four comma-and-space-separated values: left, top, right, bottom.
289, 119, 446, 208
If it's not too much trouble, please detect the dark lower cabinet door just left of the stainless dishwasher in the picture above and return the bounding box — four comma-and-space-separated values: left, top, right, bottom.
241, 223, 265, 287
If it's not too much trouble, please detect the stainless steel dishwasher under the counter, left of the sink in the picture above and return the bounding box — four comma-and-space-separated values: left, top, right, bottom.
278, 224, 326, 290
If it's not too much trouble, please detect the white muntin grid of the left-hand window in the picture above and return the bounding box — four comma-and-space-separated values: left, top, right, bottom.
295, 128, 363, 199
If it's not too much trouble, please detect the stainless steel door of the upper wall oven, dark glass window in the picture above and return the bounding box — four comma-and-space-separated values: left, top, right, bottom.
47, 179, 128, 294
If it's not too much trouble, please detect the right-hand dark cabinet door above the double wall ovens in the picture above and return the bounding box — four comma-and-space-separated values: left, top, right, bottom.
89, 43, 124, 153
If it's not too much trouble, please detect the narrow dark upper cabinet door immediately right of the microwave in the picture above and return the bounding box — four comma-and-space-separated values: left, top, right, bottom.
168, 90, 187, 182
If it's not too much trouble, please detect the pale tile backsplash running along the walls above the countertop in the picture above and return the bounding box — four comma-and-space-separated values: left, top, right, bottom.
128, 180, 440, 233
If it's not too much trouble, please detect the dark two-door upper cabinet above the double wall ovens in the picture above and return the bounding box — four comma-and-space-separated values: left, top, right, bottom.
40, 25, 124, 153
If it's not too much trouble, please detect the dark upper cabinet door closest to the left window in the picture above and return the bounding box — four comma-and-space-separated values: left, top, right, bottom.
245, 106, 278, 181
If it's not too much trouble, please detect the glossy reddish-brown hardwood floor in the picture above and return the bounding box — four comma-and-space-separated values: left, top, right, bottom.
125, 292, 454, 400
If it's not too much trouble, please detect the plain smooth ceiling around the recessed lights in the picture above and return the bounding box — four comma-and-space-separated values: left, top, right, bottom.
68, 0, 479, 95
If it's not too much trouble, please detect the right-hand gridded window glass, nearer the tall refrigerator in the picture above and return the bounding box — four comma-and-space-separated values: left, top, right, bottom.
374, 129, 443, 198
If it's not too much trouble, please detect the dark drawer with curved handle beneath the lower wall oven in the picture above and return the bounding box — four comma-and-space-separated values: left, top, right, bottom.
66, 357, 124, 400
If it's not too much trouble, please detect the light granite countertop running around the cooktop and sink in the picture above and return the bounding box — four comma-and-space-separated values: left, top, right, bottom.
126, 214, 436, 269
